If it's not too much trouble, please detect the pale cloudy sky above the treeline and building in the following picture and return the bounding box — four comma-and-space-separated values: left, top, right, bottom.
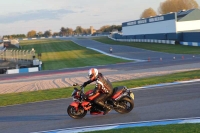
0, 0, 200, 36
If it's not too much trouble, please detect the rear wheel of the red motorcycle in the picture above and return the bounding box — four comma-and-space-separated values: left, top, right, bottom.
114, 97, 134, 114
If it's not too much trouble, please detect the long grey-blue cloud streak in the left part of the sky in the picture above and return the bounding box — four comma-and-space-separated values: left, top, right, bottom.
0, 9, 76, 24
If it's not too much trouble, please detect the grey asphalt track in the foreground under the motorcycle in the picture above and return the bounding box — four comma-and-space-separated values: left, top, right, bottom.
0, 82, 200, 133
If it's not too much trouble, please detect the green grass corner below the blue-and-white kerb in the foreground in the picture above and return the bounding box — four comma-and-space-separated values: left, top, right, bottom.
87, 123, 200, 133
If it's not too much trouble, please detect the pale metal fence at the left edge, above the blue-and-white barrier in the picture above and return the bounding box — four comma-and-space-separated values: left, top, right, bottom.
0, 50, 35, 62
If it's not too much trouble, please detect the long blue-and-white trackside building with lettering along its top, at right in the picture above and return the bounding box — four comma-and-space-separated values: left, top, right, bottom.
112, 9, 200, 42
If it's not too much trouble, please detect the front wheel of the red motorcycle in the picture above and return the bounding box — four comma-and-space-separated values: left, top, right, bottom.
67, 105, 87, 119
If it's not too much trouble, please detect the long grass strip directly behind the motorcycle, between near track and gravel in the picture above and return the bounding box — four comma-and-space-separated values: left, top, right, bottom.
0, 70, 200, 106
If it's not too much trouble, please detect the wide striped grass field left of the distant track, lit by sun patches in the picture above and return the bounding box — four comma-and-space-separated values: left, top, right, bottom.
20, 39, 129, 70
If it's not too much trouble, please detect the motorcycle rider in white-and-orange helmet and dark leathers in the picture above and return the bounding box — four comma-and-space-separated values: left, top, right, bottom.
82, 68, 113, 115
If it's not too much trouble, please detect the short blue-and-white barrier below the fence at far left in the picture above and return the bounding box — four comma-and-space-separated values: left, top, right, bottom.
6, 67, 39, 74
